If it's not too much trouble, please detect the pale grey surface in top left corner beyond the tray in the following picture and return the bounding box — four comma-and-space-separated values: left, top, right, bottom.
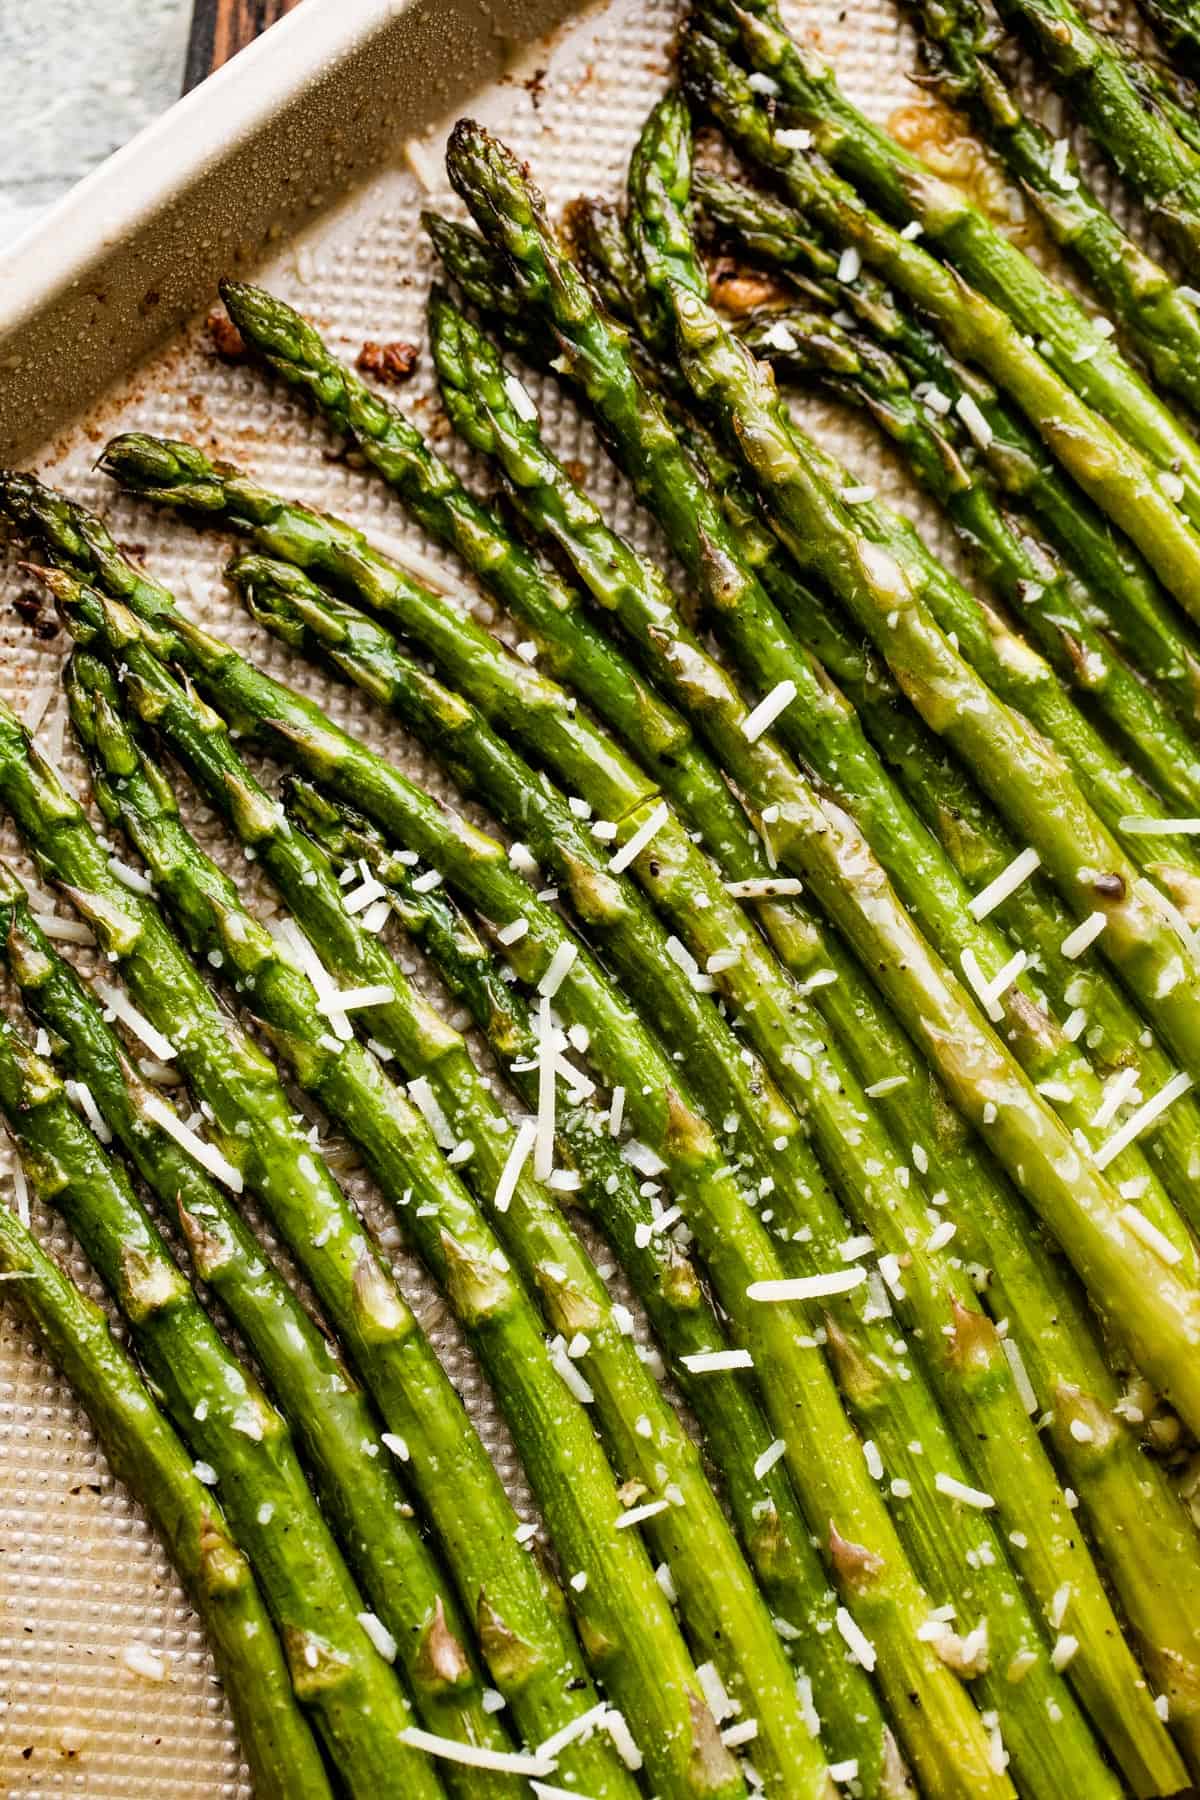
0, 0, 191, 243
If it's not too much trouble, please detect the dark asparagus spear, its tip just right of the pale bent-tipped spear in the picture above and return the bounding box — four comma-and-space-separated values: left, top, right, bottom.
694, 169, 1200, 752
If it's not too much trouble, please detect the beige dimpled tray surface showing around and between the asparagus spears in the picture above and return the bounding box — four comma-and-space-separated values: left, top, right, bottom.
0, 0, 1165, 1800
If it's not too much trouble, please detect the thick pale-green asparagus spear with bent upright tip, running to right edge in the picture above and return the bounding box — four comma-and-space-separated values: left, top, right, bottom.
635, 87, 1200, 1152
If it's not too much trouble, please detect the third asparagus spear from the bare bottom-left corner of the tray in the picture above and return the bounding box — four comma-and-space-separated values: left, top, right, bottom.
0, 875, 515, 1796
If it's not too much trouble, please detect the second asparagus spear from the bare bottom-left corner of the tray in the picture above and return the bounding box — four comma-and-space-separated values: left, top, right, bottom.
0, 993, 443, 1800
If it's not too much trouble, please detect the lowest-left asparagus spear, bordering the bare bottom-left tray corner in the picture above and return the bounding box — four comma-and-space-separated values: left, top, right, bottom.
0, 1168, 333, 1800
